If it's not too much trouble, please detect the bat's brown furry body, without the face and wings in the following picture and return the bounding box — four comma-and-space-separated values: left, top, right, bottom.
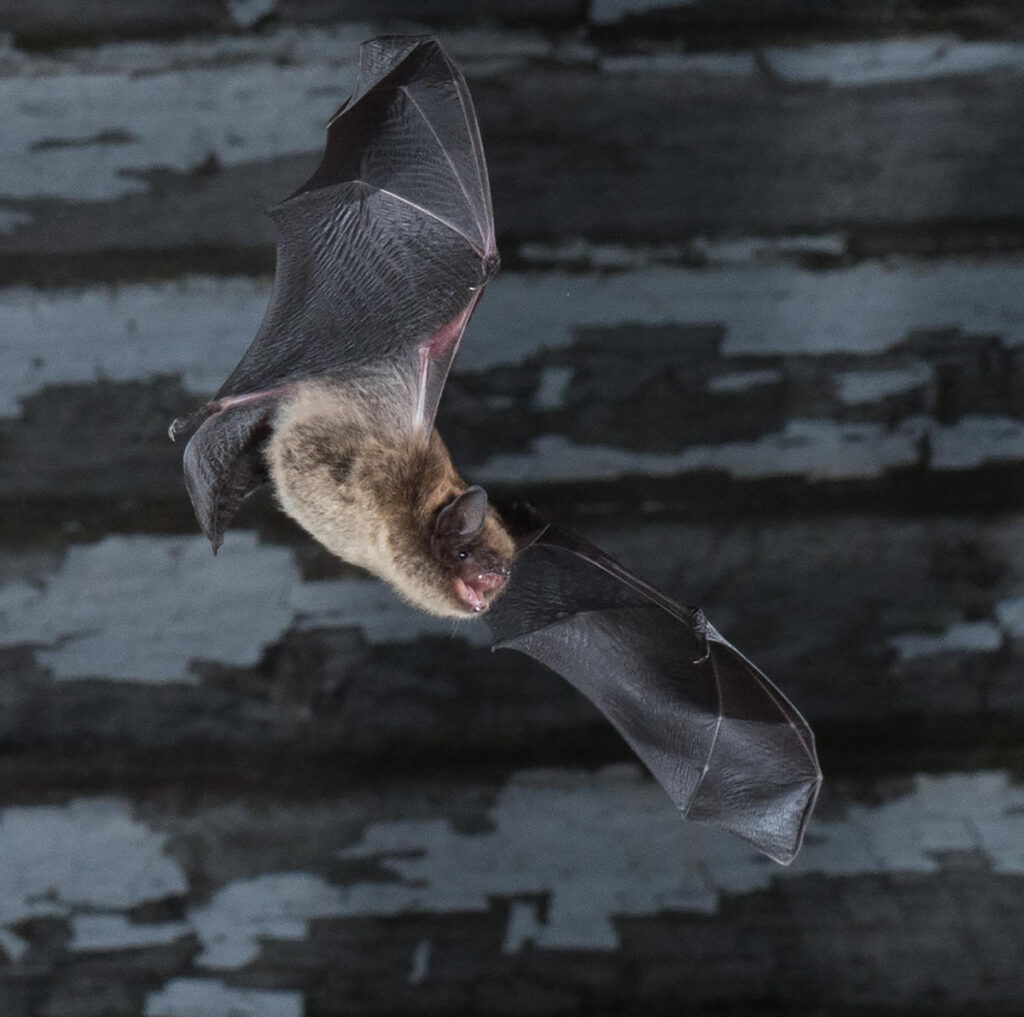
267, 376, 515, 618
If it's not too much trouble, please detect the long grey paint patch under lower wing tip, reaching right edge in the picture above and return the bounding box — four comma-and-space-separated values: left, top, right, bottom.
174, 765, 1024, 968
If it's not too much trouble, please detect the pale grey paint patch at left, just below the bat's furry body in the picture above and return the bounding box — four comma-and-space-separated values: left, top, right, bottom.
0, 532, 485, 682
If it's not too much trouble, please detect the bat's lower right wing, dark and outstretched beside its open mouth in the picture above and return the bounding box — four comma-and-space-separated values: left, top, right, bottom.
485, 507, 821, 864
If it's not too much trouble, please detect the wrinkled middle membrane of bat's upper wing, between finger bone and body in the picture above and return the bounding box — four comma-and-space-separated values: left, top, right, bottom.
217, 181, 485, 403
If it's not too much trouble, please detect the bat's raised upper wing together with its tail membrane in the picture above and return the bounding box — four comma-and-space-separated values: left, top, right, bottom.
171, 37, 498, 548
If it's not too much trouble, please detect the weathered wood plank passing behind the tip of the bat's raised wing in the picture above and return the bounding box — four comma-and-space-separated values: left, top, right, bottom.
0, 32, 1024, 280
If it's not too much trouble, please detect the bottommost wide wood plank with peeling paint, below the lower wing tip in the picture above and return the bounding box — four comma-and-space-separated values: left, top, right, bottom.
0, 767, 1024, 1017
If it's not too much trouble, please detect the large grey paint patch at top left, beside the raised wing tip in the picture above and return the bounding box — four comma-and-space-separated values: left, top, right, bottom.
6, 61, 356, 201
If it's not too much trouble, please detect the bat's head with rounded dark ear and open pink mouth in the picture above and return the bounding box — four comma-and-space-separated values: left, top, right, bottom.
430, 486, 515, 615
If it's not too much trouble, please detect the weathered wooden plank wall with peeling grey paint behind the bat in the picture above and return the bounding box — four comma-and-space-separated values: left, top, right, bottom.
0, 0, 1024, 1017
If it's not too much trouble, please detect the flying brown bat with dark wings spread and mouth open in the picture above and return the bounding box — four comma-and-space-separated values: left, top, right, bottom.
170, 37, 821, 863
